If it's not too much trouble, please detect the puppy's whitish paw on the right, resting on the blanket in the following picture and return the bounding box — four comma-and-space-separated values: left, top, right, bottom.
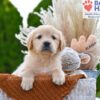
53, 72, 65, 85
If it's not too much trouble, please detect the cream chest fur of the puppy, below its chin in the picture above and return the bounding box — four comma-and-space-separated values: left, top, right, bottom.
25, 55, 59, 74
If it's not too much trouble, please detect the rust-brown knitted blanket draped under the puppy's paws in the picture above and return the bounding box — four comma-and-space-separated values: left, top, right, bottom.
0, 74, 84, 100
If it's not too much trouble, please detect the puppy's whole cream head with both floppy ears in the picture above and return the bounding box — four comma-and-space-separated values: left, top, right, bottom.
27, 25, 65, 54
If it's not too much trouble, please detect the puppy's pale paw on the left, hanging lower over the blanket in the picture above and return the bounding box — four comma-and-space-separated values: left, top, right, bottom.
21, 77, 34, 91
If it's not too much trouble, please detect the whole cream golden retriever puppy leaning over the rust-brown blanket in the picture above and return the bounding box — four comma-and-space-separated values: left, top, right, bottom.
13, 25, 65, 90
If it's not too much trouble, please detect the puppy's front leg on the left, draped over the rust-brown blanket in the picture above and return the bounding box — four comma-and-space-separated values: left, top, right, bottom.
21, 72, 34, 91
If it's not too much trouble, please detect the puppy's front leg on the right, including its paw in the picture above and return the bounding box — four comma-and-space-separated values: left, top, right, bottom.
52, 69, 65, 85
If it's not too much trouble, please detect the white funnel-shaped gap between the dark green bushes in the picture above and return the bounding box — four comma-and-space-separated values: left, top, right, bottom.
10, 0, 41, 27
